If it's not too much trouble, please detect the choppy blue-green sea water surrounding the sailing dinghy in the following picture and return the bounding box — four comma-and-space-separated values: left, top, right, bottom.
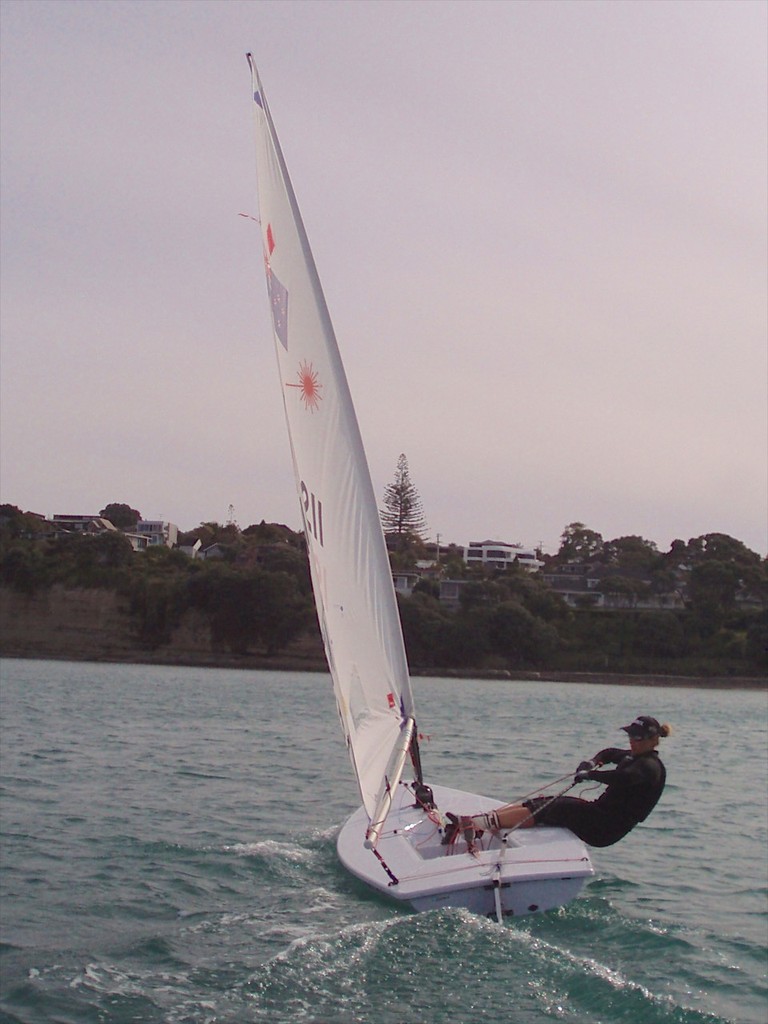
0, 660, 768, 1024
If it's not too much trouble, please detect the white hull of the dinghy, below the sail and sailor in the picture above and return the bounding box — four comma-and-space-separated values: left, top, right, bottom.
337, 782, 594, 920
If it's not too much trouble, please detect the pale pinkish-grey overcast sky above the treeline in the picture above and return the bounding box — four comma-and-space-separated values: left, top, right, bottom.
0, 0, 768, 555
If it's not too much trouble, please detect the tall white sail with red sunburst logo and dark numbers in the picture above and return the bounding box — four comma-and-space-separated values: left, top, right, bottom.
249, 55, 414, 820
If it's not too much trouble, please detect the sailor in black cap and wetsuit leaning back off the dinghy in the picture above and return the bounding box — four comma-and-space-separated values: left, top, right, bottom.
443, 715, 672, 846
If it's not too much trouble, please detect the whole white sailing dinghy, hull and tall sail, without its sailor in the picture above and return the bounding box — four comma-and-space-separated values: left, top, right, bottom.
248, 54, 593, 921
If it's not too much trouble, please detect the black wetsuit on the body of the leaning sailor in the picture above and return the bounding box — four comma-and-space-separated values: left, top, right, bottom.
524, 746, 667, 846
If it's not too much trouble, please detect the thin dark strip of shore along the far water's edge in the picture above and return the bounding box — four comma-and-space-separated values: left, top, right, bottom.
0, 650, 768, 690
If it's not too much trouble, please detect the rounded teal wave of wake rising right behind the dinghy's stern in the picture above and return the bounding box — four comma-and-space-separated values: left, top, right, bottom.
247, 900, 726, 1024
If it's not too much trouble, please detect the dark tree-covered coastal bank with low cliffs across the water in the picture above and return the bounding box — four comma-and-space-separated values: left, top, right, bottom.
0, 505, 768, 687
